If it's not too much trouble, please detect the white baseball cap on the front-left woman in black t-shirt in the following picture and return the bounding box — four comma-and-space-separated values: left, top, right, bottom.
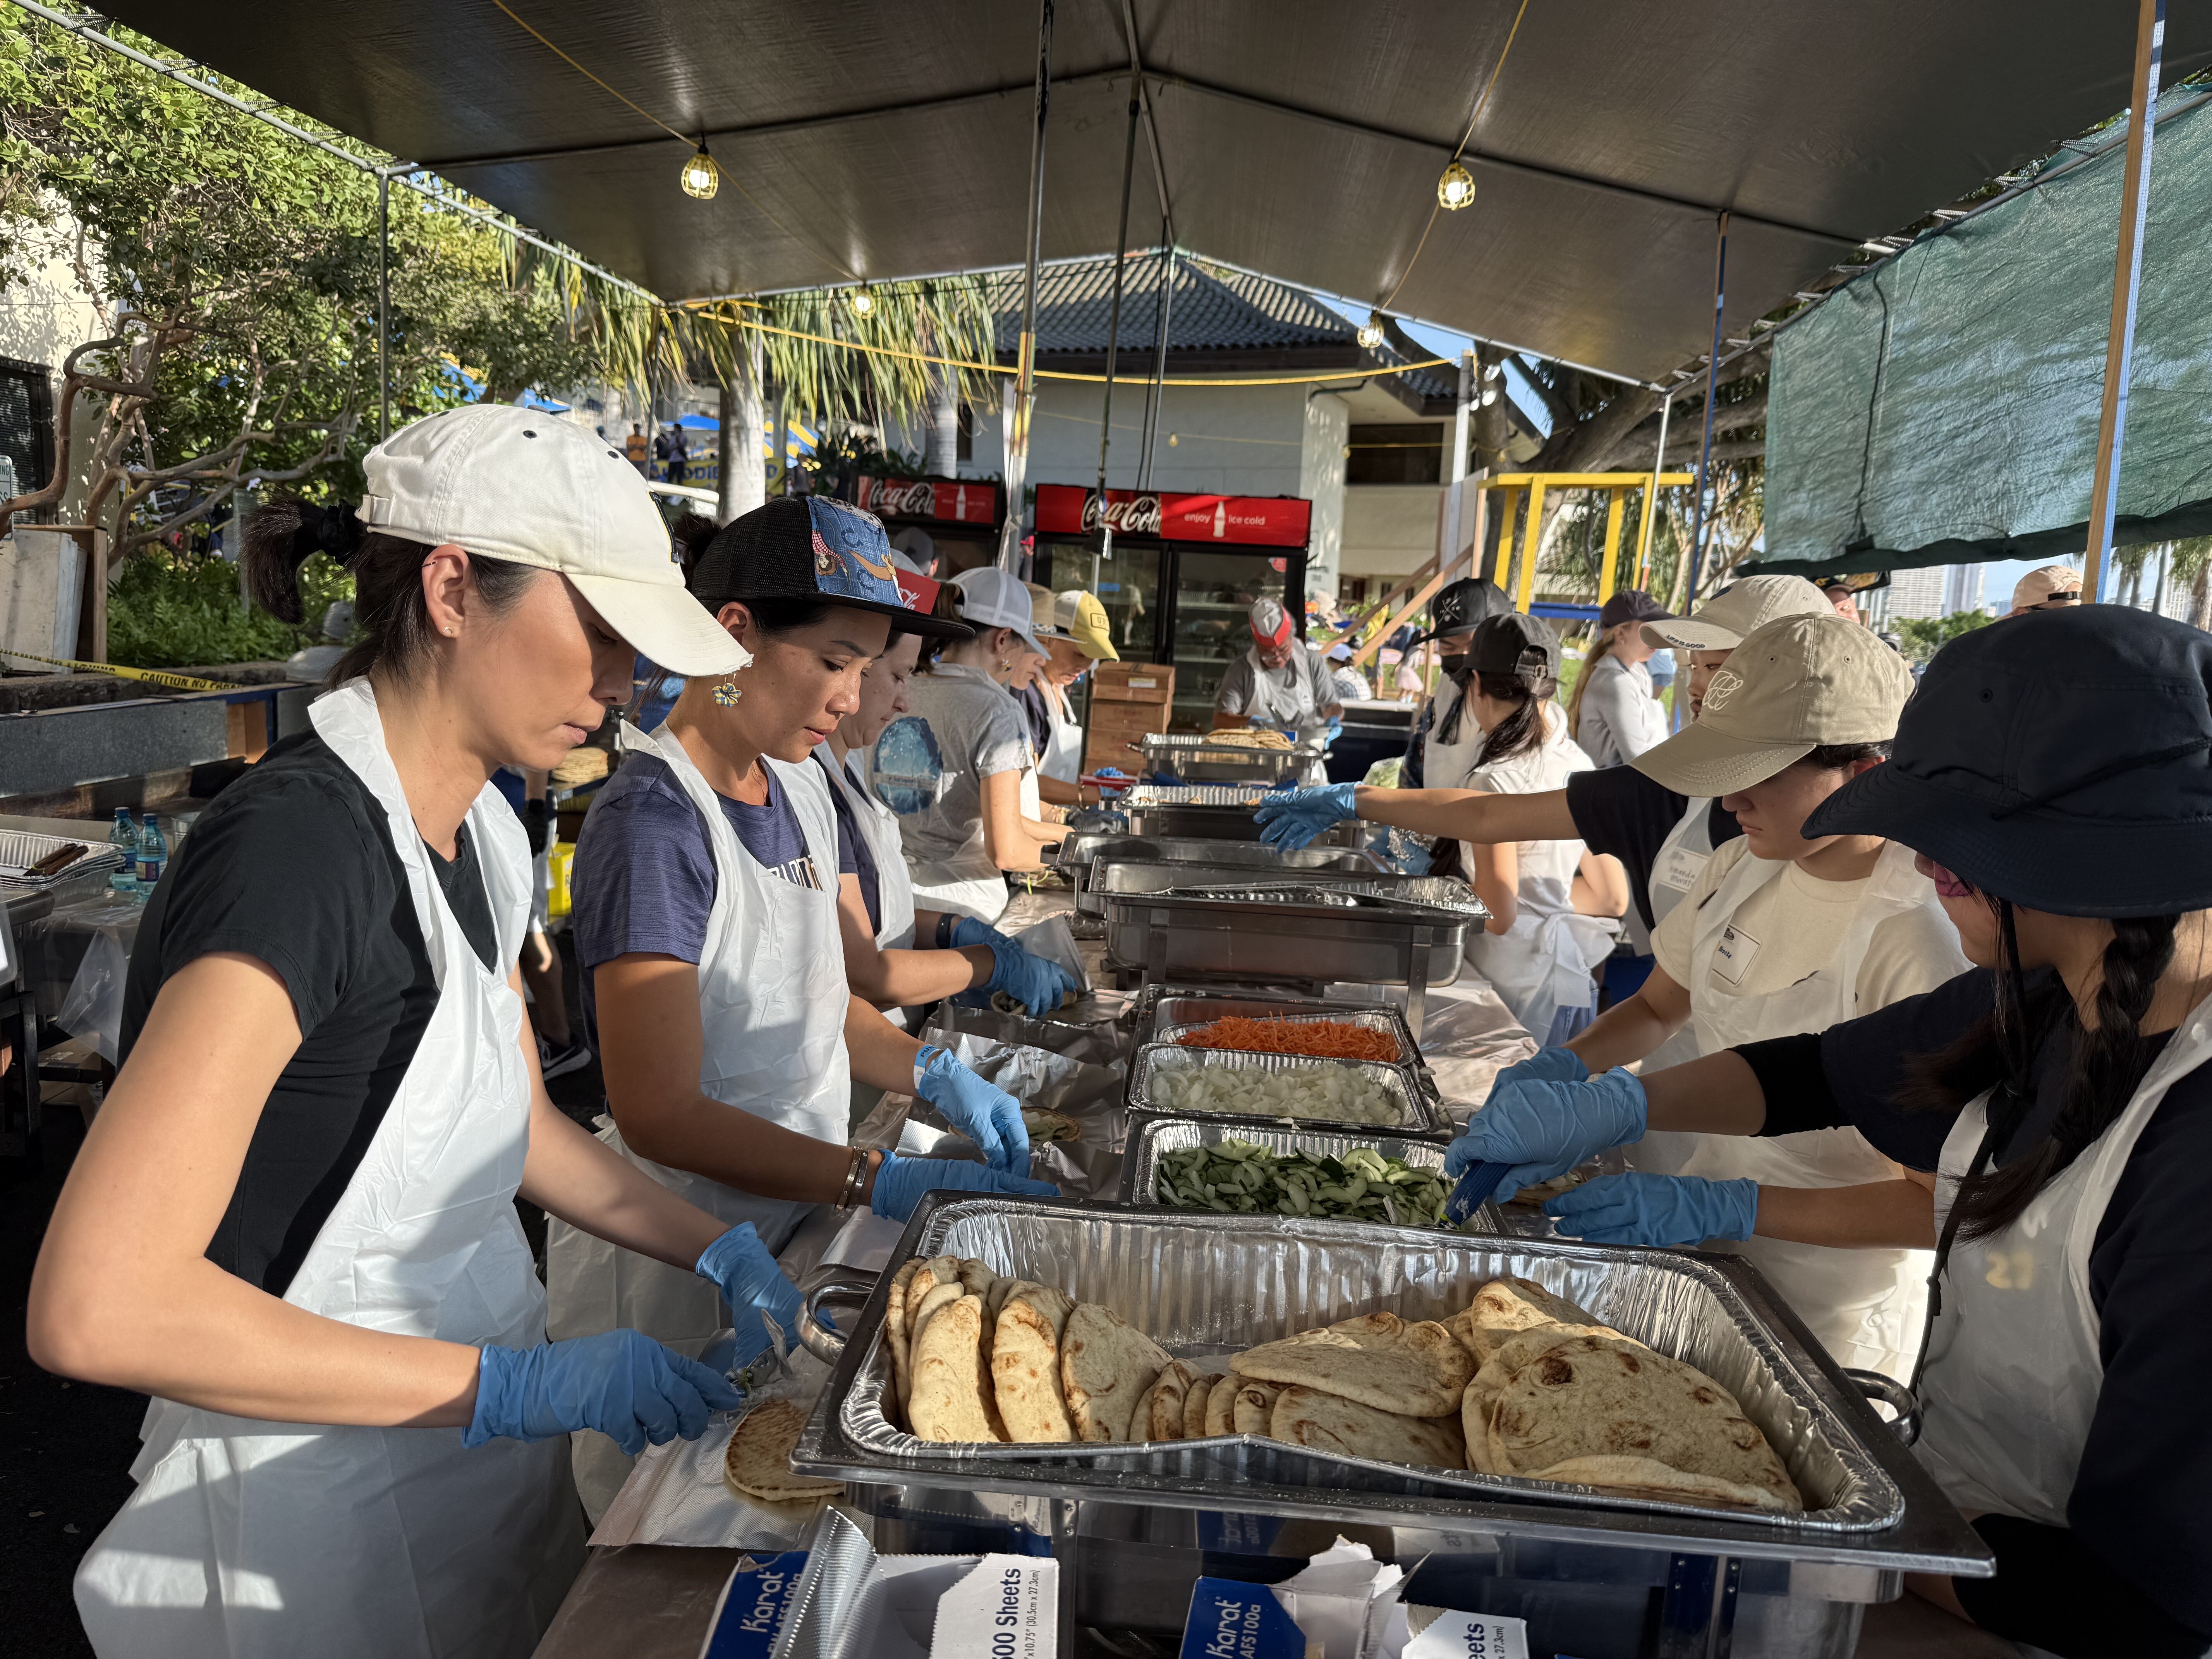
356, 403, 752, 677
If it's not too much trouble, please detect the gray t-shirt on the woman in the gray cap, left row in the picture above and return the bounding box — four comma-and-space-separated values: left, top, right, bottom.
869, 664, 1029, 885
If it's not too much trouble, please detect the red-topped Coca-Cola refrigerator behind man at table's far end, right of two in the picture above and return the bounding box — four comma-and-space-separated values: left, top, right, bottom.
1035, 484, 1314, 732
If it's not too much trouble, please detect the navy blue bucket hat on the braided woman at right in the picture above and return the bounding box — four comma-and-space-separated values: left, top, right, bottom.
1805, 604, 2212, 916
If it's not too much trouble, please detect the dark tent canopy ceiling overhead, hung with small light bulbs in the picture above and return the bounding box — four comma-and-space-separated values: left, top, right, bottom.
104, 0, 2212, 380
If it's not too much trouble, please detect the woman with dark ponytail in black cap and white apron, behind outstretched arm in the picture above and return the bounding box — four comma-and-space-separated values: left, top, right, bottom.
1438, 611, 1628, 1042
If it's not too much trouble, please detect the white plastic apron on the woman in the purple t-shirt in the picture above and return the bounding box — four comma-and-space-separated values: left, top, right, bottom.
546, 726, 852, 1354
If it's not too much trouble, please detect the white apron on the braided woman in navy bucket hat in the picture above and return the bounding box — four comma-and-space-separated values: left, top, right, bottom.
1913, 1002, 2212, 1526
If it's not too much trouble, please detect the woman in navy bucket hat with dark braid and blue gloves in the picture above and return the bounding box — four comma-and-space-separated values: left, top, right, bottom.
1442, 606, 2212, 1655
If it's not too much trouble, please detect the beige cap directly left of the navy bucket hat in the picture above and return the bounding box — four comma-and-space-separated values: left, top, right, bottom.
1630, 615, 1913, 796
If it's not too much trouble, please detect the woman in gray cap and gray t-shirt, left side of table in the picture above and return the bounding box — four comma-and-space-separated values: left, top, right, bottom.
869, 566, 1066, 922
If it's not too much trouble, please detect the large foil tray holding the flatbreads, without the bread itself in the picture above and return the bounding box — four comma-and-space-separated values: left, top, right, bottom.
792, 1192, 1920, 1559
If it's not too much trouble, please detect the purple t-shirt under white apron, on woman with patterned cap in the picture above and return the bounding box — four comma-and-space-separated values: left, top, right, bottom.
568, 754, 852, 1048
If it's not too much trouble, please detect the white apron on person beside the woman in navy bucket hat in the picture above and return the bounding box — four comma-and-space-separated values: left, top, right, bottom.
1681, 841, 1964, 1382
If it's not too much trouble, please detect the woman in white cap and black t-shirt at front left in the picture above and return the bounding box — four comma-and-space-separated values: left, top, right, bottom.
29, 405, 796, 1659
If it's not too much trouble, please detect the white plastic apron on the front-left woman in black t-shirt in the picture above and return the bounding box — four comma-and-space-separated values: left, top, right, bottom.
75, 679, 584, 1659
